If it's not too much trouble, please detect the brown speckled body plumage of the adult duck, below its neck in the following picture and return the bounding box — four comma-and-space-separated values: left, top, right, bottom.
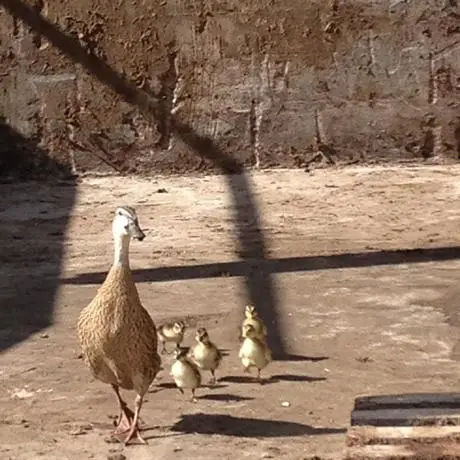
77, 266, 161, 394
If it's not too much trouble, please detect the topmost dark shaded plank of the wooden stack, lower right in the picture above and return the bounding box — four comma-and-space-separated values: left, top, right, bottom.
354, 393, 460, 410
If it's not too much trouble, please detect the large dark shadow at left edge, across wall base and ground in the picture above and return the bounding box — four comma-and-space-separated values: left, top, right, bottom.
0, 116, 76, 352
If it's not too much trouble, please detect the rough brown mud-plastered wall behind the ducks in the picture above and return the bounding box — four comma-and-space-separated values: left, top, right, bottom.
0, 0, 460, 173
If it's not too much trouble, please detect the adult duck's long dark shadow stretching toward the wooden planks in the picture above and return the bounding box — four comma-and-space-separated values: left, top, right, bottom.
171, 413, 346, 438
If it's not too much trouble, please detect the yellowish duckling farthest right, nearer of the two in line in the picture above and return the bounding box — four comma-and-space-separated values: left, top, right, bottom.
238, 324, 272, 384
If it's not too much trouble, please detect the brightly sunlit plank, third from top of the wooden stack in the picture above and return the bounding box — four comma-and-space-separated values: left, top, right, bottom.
347, 426, 460, 446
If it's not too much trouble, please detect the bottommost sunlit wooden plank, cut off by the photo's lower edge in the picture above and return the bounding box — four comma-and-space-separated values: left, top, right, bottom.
345, 444, 460, 460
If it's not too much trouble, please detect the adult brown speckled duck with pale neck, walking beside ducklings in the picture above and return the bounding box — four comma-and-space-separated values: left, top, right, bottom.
77, 206, 161, 445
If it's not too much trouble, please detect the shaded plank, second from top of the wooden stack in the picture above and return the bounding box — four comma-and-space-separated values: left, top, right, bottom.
351, 407, 460, 426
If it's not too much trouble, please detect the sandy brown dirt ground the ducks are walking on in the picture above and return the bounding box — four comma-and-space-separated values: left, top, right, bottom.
0, 166, 460, 460
